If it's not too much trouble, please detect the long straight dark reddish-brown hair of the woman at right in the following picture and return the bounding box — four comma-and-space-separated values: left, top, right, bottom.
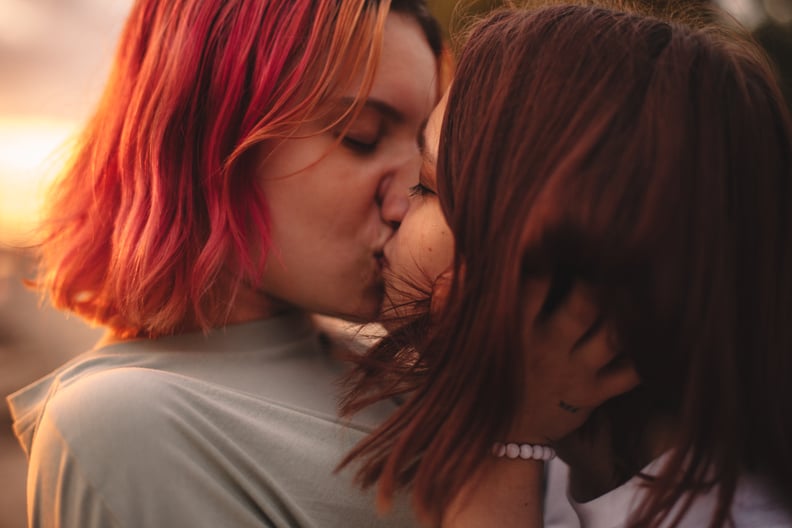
345, 5, 792, 526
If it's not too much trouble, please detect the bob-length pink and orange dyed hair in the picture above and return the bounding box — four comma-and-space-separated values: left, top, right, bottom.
36, 0, 442, 337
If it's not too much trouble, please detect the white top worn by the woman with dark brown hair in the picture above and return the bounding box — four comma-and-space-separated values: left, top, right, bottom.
545, 456, 792, 528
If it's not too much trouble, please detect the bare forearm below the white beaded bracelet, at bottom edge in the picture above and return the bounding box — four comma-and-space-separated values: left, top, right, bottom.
442, 457, 544, 528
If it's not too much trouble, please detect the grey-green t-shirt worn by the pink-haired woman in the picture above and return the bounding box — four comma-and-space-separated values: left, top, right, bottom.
9, 314, 417, 528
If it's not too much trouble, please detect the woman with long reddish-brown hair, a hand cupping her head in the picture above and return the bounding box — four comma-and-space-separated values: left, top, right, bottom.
347, 6, 792, 527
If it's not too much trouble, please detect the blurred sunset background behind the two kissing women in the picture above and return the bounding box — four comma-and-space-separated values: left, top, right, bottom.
0, 0, 792, 528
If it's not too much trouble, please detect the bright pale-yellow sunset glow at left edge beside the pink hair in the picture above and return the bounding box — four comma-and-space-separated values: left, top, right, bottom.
0, 118, 77, 245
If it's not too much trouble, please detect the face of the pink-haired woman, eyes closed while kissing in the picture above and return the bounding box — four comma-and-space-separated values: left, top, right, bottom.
240, 13, 437, 321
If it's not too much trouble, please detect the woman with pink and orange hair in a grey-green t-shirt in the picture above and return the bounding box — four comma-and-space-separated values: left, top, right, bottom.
10, 0, 442, 528
